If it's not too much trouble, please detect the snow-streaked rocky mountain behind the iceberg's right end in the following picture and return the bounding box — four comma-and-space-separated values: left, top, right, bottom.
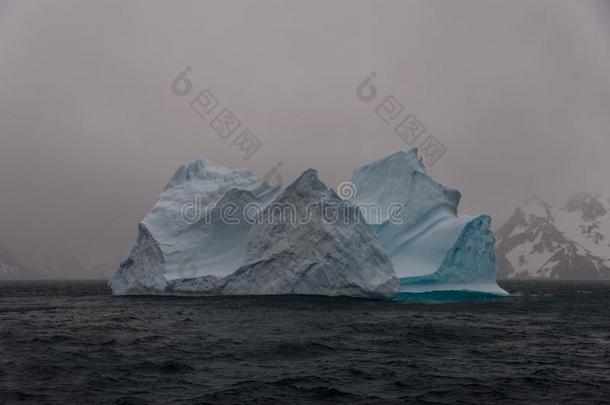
497, 193, 610, 279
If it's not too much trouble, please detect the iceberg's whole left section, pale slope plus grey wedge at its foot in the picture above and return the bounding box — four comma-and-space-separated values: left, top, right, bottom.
110, 160, 280, 295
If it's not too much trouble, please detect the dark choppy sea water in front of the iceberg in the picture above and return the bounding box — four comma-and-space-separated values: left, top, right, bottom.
0, 282, 610, 404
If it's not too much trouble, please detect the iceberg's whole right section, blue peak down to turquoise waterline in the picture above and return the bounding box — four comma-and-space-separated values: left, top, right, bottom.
352, 148, 506, 294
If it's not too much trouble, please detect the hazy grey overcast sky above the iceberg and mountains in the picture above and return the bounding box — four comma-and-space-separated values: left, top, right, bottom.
0, 0, 610, 276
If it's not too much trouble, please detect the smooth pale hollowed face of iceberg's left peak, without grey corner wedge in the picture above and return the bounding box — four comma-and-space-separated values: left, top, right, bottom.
143, 160, 280, 280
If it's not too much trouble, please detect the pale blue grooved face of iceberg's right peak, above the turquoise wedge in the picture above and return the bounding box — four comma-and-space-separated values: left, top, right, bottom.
352, 149, 468, 277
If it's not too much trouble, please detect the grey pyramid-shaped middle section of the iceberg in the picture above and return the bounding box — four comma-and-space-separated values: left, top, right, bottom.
185, 170, 398, 298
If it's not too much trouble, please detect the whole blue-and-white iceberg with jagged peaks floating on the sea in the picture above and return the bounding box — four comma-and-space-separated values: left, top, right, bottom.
110, 149, 505, 298
